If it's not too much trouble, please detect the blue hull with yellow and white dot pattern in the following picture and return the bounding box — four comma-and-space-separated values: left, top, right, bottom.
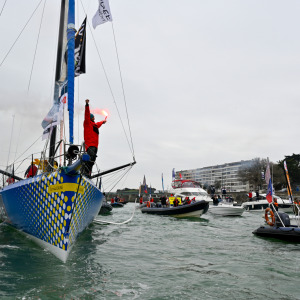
0, 170, 103, 262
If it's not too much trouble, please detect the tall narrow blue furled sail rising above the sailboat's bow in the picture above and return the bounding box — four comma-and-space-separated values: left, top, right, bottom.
67, 0, 76, 144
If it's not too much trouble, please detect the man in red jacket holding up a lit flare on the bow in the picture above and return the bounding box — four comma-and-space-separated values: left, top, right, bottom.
83, 99, 106, 176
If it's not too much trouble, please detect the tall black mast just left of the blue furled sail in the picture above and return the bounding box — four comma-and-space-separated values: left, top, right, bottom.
49, 0, 66, 169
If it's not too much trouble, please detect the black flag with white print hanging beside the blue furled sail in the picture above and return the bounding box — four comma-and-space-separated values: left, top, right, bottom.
74, 17, 86, 77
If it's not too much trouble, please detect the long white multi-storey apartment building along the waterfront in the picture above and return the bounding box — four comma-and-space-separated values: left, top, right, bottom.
176, 160, 253, 192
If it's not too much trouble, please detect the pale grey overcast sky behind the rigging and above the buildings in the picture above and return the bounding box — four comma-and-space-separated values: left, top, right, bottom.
0, 0, 300, 189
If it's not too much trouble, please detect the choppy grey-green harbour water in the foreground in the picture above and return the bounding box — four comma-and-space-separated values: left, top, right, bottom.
0, 203, 300, 300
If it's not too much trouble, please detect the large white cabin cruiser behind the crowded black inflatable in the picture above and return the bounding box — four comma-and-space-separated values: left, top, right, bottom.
169, 179, 212, 203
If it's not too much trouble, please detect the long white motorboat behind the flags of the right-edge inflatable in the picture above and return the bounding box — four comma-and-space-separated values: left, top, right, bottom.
242, 194, 293, 213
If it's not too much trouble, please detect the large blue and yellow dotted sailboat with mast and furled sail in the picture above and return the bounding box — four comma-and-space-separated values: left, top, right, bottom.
0, 0, 135, 262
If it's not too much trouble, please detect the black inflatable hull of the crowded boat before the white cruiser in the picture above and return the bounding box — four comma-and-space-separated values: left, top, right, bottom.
141, 200, 209, 218
